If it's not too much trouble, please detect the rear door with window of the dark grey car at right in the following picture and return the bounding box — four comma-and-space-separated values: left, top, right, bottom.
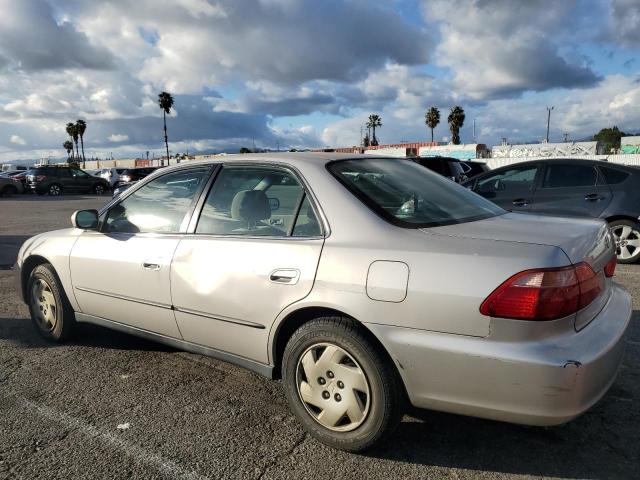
532, 163, 611, 217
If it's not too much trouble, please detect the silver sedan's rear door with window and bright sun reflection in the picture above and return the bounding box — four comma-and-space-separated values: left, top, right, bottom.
171, 165, 324, 363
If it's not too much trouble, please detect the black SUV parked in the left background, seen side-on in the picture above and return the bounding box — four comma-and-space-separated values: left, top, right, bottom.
27, 166, 110, 196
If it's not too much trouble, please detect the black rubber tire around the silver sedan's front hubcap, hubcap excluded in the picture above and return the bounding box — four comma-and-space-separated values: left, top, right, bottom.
27, 263, 76, 342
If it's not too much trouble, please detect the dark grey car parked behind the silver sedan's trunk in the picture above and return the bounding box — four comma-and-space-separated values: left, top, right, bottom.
465, 159, 640, 263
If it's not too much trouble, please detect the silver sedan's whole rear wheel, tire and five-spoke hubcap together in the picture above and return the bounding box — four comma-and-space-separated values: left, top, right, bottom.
282, 317, 404, 452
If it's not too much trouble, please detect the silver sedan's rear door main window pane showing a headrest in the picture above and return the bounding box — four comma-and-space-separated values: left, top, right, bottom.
196, 166, 303, 237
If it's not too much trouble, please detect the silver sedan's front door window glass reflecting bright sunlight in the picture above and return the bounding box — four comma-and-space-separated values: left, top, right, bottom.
104, 167, 210, 233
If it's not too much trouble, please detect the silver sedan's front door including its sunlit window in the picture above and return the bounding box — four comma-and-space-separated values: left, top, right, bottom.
70, 166, 211, 338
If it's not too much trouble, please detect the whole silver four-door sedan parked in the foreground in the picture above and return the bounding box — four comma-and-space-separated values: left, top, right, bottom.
15, 153, 632, 451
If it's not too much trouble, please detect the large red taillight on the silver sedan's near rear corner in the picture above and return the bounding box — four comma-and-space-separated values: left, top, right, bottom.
480, 263, 604, 320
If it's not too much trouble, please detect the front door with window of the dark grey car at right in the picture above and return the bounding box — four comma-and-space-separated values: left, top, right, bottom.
473, 164, 538, 212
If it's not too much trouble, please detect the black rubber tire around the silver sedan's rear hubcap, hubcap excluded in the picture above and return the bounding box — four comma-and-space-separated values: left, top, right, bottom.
282, 316, 405, 452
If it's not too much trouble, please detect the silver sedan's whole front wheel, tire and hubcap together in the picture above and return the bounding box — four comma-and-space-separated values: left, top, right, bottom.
27, 263, 75, 342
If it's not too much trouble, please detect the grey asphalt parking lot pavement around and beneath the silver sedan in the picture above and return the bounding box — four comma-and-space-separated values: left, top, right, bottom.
0, 195, 640, 480
